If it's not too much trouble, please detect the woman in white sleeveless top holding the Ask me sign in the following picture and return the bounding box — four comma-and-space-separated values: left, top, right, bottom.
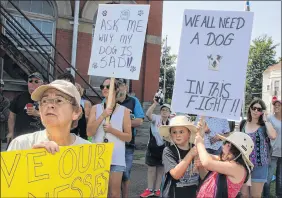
87, 78, 132, 198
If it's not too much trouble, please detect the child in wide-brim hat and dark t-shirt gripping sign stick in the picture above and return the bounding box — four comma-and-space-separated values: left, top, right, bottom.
159, 116, 199, 198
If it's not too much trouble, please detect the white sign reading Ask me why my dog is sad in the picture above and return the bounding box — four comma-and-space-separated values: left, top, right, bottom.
88, 4, 150, 80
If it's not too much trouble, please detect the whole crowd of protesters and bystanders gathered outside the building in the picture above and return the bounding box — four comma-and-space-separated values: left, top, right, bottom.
0, 72, 282, 198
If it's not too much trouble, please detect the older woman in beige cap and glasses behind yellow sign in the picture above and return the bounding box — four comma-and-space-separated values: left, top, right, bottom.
8, 80, 90, 154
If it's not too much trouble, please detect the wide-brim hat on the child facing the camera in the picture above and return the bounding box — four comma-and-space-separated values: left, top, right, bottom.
159, 115, 197, 144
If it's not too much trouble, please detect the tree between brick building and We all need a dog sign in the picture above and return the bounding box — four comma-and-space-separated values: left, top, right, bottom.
159, 41, 177, 103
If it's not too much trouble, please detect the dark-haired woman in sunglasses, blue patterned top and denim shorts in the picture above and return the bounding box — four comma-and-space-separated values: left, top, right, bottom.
240, 99, 277, 197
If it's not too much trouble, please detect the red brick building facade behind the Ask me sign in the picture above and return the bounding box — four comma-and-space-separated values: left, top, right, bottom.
0, 0, 163, 105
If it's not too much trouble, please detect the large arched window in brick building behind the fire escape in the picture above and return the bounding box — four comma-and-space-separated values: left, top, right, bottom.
7, 0, 55, 54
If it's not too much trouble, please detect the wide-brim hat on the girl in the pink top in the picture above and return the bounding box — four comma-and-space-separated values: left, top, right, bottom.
218, 132, 254, 167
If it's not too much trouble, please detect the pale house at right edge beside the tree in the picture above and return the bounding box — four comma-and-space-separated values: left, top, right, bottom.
262, 61, 281, 113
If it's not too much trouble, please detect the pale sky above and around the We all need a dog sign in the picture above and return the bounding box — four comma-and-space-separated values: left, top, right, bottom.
162, 1, 282, 58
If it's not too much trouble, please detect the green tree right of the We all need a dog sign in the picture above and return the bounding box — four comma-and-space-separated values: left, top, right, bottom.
245, 35, 279, 110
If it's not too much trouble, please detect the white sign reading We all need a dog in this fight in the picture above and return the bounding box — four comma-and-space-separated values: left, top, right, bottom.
172, 10, 253, 120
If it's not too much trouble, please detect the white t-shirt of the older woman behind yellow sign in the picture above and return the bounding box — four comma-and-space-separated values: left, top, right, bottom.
7, 130, 91, 151
